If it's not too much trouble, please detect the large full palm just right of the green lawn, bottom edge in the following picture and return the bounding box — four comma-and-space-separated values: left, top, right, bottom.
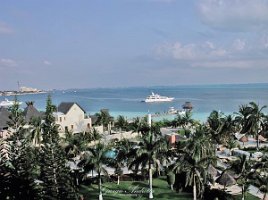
173, 125, 216, 200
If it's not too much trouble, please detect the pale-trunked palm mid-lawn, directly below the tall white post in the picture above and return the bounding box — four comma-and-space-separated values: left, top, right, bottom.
129, 126, 168, 199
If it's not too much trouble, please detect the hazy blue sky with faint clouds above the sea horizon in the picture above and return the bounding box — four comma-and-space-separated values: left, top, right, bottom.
0, 0, 268, 90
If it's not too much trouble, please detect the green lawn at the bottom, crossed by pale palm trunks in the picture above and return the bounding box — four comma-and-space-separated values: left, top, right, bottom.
80, 177, 193, 200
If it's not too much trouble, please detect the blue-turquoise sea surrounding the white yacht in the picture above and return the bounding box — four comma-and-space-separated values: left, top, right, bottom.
0, 84, 268, 121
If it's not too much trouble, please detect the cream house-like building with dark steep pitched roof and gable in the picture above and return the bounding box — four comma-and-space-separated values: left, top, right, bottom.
54, 102, 92, 133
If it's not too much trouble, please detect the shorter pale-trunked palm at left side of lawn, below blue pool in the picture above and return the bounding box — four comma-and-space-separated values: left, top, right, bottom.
79, 143, 109, 200
